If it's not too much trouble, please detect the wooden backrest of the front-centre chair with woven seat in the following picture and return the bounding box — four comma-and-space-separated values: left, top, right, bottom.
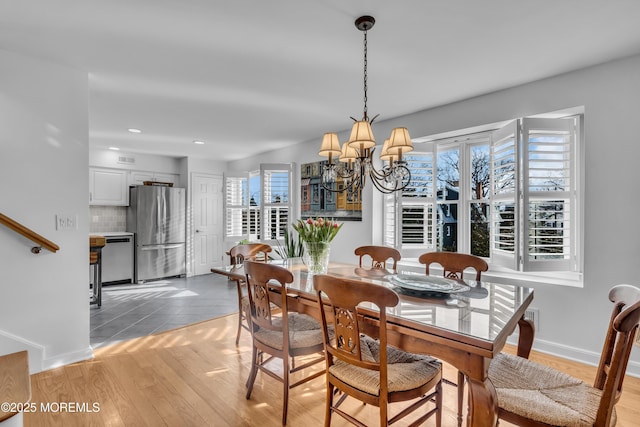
313, 274, 399, 396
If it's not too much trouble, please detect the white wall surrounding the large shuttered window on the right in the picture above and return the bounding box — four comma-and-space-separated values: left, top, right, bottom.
229, 56, 640, 375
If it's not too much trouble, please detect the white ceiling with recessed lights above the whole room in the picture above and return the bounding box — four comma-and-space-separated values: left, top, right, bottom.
0, 0, 640, 160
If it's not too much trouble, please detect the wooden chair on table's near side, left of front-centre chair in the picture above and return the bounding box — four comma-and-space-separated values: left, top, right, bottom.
244, 261, 324, 424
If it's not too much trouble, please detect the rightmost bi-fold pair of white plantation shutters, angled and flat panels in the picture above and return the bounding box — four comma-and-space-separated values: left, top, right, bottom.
491, 117, 579, 271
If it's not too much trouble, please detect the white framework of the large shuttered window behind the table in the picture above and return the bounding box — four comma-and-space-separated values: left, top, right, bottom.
383, 114, 584, 273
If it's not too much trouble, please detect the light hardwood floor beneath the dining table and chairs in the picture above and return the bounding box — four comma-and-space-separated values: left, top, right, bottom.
24, 315, 640, 427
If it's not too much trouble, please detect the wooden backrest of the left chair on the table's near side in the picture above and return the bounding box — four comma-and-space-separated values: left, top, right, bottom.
244, 261, 293, 334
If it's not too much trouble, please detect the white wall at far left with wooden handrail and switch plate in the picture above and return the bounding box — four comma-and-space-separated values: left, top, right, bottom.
0, 50, 93, 372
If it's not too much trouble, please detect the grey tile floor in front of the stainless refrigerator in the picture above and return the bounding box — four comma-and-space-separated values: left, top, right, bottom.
90, 274, 238, 348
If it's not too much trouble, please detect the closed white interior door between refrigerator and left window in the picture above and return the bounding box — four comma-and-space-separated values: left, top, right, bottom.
191, 175, 224, 275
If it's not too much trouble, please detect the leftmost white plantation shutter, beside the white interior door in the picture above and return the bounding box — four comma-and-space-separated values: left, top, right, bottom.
224, 173, 249, 241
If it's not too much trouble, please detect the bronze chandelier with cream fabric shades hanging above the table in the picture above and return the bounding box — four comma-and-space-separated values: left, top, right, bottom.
318, 16, 413, 194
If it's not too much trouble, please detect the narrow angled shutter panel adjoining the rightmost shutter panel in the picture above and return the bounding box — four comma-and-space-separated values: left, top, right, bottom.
491, 121, 520, 270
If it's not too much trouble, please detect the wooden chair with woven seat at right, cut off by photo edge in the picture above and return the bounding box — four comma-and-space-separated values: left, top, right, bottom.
489, 285, 640, 427
